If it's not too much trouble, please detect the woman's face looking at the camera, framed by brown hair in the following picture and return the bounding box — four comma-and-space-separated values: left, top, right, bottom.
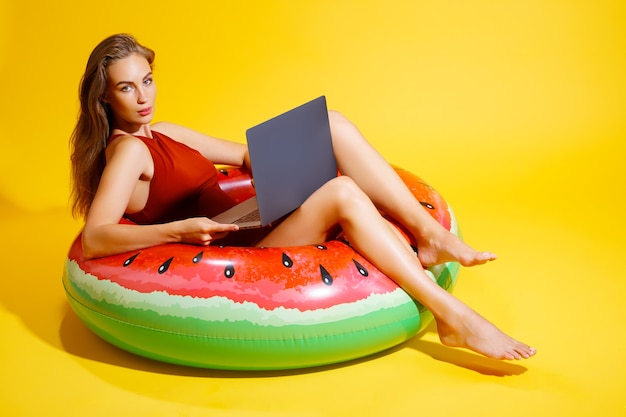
104, 54, 156, 133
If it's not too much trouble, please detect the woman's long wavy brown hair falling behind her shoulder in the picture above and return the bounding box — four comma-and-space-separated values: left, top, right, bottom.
70, 34, 154, 217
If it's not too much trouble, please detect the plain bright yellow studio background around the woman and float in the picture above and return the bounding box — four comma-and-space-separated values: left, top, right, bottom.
0, 0, 626, 416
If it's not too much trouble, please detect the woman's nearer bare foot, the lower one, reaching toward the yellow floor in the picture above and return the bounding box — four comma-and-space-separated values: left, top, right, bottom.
436, 301, 536, 360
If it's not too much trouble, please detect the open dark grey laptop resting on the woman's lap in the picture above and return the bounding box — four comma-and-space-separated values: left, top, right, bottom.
211, 96, 337, 229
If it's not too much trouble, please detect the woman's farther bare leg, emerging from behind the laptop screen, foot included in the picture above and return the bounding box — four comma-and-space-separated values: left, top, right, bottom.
329, 111, 496, 266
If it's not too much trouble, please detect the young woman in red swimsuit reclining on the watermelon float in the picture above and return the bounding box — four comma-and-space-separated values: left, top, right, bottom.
71, 35, 535, 359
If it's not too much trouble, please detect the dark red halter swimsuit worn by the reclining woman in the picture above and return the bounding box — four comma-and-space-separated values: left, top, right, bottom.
111, 131, 235, 224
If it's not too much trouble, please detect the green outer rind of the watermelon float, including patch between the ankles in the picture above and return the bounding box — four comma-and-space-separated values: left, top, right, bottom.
63, 263, 459, 370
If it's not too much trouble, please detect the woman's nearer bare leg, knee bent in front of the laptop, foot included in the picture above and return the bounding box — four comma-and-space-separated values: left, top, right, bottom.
259, 176, 535, 359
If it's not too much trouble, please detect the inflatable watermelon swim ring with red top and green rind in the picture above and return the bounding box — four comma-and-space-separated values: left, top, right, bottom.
63, 167, 459, 370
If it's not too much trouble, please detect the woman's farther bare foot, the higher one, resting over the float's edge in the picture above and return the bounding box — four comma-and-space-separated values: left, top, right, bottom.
416, 227, 496, 267
